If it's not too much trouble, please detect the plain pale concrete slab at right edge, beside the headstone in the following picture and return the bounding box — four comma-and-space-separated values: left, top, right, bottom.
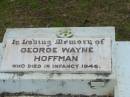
115, 41, 130, 97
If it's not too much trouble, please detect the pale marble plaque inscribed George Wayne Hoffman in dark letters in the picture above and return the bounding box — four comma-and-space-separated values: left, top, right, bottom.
0, 38, 112, 73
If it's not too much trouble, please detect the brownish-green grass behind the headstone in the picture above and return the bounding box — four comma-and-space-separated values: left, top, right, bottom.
0, 0, 130, 41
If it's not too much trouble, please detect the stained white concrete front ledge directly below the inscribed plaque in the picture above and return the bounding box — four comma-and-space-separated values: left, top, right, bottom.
0, 73, 115, 95
